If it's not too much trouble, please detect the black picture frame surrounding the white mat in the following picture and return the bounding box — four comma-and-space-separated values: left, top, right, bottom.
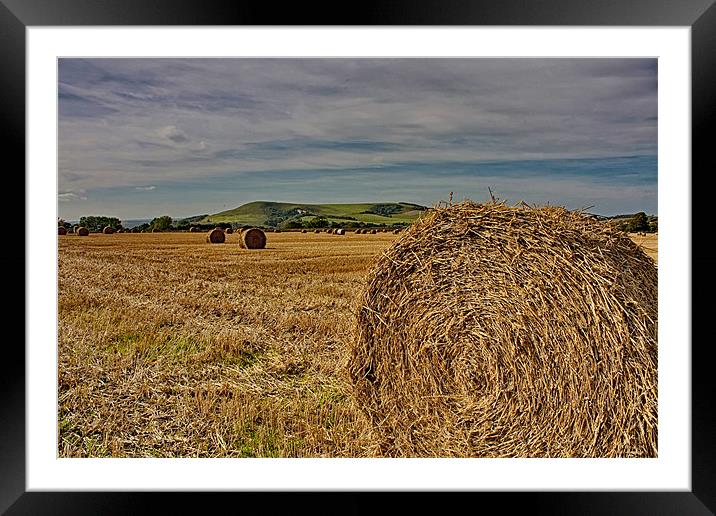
0, 0, 716, 515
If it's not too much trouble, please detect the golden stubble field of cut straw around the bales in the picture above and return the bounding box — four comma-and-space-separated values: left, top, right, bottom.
58, 232, 657, 457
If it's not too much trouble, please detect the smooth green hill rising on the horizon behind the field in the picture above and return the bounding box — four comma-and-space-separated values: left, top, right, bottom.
199, 201, 427, 226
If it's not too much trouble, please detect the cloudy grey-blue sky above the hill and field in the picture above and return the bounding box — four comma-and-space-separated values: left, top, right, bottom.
57, 58, 658, 220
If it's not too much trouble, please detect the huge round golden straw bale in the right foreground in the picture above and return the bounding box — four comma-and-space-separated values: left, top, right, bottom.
348, 202, 658, 457
